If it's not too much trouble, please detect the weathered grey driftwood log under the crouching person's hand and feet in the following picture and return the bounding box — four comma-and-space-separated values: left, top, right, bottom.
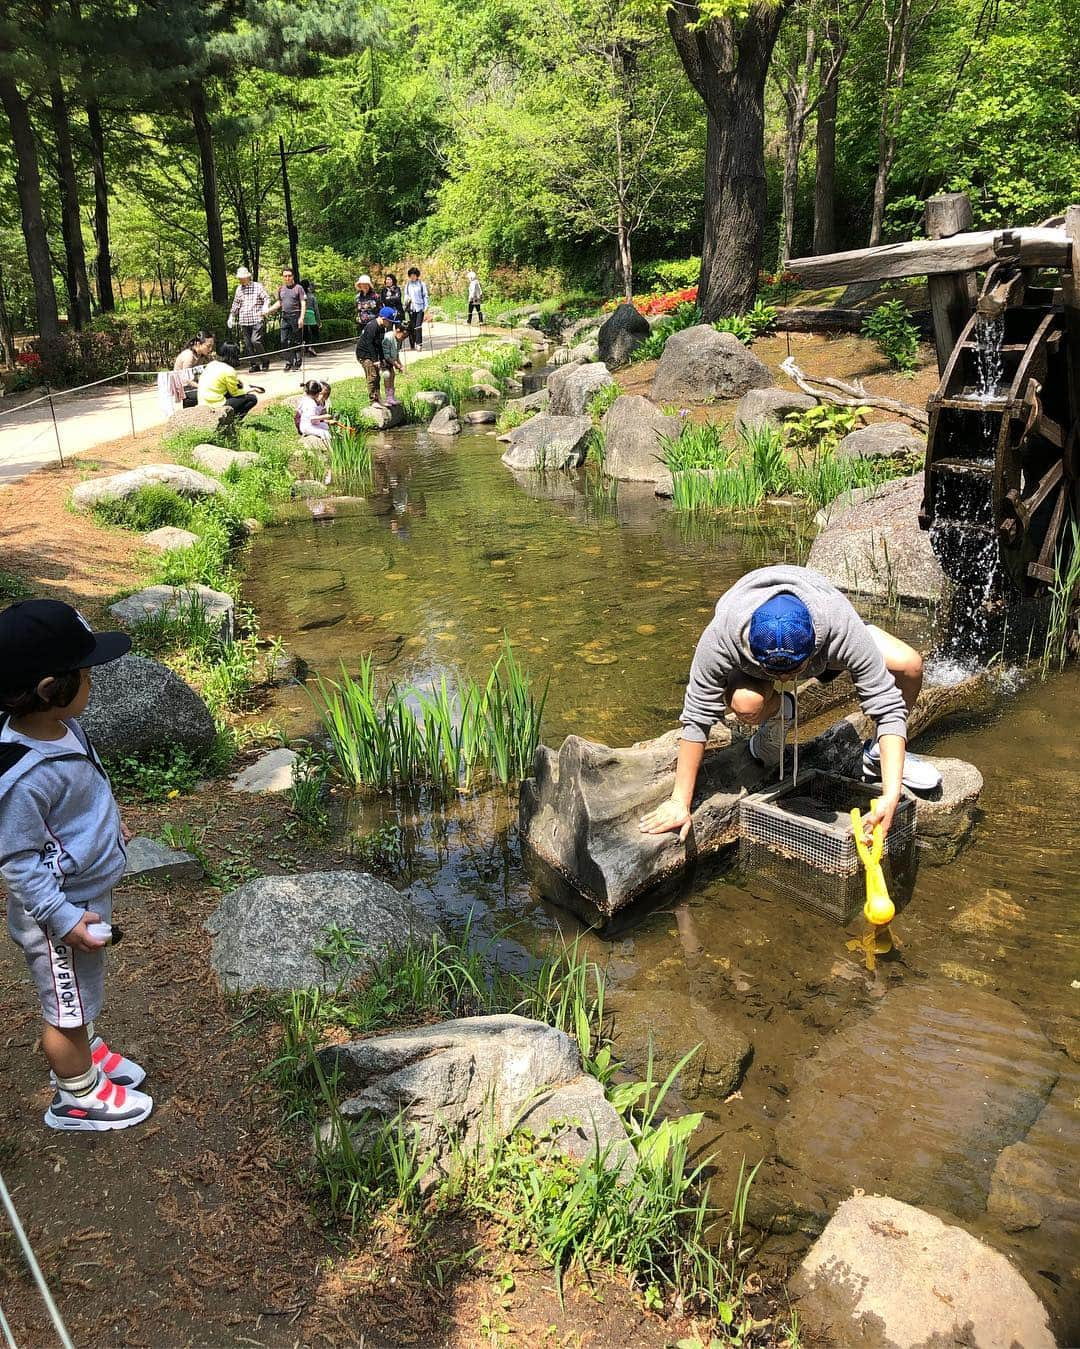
519, 675, 994, 919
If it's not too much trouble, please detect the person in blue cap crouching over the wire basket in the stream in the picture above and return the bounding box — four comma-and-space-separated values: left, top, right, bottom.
640, 567, 941, 842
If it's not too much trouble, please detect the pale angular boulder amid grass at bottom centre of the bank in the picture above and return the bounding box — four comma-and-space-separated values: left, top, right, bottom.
320, 1016, 632, 1167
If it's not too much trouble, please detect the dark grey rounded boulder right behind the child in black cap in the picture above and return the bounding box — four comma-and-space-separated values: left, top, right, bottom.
81, 656, 217, 755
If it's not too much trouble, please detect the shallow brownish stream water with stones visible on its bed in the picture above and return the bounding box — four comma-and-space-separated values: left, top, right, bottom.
245, 415, 1080, 1344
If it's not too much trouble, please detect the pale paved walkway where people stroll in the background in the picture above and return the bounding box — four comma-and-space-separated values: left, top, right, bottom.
0, 324, 492, 486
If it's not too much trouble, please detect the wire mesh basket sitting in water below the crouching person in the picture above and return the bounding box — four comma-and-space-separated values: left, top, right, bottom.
739, 769, 916, 924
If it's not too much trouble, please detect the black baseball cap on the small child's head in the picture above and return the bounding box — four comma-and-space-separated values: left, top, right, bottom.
0, 599, 131, 693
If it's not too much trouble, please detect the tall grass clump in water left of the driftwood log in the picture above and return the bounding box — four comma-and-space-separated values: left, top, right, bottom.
311, 642, 547, 792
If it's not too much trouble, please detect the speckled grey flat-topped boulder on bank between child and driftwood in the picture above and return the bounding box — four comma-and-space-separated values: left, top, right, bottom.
206, 871, 438, 992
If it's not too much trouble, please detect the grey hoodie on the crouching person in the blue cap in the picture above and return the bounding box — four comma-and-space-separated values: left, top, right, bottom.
680, 567, 907, 742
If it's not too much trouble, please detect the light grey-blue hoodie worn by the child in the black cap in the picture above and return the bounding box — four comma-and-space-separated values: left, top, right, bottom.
0, 715, 127, 940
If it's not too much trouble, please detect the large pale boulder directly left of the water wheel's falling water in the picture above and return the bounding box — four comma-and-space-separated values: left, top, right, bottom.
808, 473, 945, 602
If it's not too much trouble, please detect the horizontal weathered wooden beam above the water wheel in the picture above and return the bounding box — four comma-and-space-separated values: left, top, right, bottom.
783, 229, 1072, 286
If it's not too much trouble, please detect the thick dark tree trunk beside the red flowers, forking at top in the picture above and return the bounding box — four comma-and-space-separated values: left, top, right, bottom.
667, 0, 790, 321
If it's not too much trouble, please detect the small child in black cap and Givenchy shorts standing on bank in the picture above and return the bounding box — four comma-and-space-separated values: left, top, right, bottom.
0, 599, 154, 1133
